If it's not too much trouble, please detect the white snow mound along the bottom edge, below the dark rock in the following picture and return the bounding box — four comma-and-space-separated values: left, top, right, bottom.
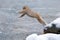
26, 33, 60, 40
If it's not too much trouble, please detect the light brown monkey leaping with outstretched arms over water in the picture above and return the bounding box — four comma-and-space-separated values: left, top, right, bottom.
19, 6, 47, 25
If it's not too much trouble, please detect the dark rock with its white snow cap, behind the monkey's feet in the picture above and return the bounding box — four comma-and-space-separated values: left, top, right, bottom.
44, 18, 60, 34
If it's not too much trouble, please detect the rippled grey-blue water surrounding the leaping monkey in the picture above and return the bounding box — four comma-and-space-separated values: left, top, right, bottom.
0, 0, 60, 40
